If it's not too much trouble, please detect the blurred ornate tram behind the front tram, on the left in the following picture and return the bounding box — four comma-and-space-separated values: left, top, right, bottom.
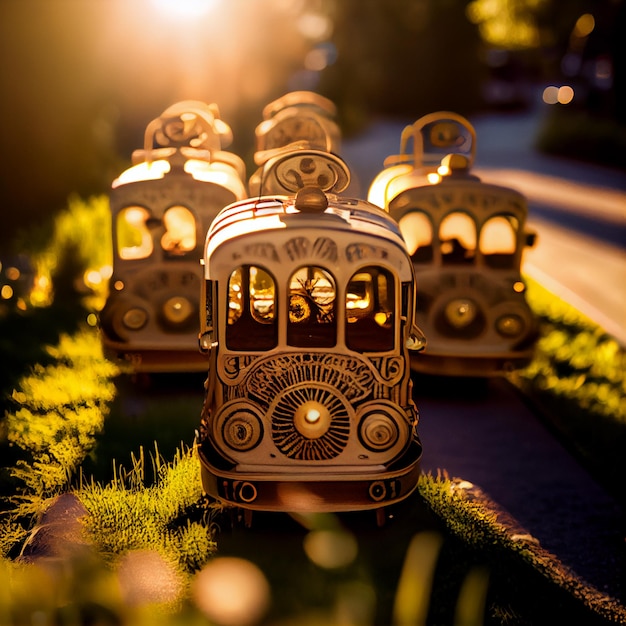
100, 101, 246, 372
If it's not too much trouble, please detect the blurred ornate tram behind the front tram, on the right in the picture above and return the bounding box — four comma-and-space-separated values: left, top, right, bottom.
368, 111, 537, 377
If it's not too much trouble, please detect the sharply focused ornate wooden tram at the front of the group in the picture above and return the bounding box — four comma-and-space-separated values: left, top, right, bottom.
198, 149, 423, 513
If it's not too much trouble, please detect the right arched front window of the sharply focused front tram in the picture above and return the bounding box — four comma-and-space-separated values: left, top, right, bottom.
346, 266, 395, 352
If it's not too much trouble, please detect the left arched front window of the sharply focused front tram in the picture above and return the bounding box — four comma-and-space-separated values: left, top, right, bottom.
226, 265, 278, 350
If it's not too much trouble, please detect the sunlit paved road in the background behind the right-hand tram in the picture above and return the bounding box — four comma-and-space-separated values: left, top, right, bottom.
342, 105, 626, 345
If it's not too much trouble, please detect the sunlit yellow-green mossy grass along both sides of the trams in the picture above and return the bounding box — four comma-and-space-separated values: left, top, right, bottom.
0, 194, 626, 626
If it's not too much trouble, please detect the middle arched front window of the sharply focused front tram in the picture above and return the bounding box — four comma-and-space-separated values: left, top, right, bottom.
287, 267, 337, 348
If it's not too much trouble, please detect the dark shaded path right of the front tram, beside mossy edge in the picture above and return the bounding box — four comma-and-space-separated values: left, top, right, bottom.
415, 376, 626, 599
